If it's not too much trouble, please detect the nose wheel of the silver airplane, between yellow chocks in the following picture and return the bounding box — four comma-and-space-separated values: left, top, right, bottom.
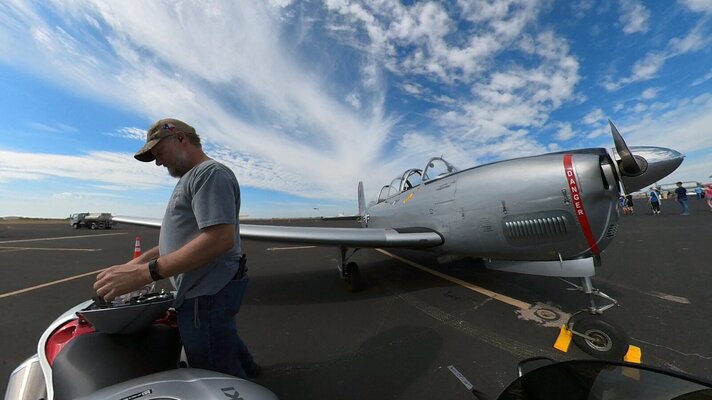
573, 315, 628, 361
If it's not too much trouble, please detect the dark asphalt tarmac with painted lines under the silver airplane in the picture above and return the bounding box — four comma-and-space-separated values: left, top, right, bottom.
0, 198, 712, 399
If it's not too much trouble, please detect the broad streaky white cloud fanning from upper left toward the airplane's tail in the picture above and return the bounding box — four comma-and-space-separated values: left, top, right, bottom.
0, 0, 393, 202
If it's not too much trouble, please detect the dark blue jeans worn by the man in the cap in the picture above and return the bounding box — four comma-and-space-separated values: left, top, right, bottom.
176, 274, 255, 379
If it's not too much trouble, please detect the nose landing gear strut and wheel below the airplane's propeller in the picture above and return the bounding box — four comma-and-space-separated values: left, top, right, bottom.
562, 276, 629, 361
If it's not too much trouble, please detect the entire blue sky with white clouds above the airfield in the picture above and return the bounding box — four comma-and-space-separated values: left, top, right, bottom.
0, 0, 712, 217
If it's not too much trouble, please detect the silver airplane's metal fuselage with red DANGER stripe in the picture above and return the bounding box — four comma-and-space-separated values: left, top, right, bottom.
367, 149, 619, 261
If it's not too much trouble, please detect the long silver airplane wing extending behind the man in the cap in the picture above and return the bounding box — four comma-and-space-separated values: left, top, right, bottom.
113, 216, 443, 248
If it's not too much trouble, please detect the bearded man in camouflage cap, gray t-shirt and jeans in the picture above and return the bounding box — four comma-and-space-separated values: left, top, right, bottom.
94, 118, 260, 378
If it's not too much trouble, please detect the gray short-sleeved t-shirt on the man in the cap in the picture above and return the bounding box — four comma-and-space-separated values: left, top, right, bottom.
158, 160, 241, 308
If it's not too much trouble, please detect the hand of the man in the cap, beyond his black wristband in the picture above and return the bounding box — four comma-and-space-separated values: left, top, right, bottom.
94, 261, 153, 301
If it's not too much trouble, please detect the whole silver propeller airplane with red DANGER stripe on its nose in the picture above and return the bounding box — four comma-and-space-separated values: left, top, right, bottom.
115, 121, 684, 358
